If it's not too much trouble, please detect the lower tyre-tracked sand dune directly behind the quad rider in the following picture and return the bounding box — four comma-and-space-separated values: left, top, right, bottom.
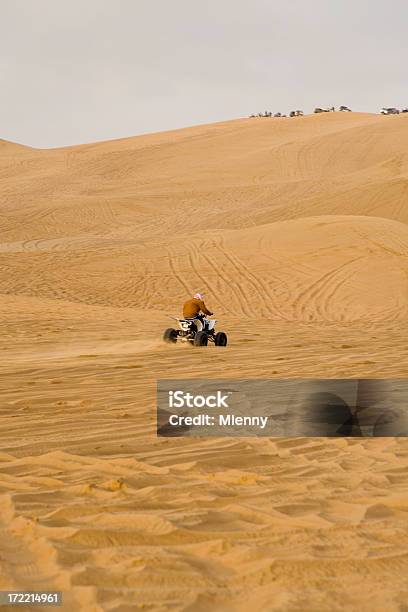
0, 215, 408, 321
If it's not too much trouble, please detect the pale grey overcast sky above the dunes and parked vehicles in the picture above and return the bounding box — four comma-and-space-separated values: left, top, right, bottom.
0, 0, 408, 147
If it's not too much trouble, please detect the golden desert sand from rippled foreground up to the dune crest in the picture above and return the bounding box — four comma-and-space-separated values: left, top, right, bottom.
0, 113, 408, 612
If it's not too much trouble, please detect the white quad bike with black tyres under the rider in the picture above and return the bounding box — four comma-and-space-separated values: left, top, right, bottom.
163, 315, 227, 346
